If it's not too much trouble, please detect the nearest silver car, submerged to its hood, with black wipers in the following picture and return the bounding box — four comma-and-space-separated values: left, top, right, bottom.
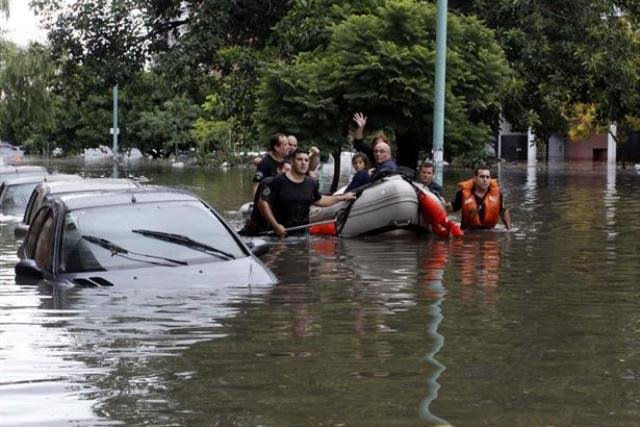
15, 188, 277, 291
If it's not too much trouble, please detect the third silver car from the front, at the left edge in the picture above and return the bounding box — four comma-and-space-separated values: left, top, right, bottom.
0, 174, 82, 218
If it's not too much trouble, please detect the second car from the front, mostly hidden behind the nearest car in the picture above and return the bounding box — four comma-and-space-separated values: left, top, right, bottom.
14, 178, 140, 238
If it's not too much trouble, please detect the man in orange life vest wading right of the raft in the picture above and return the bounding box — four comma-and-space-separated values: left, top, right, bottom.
447, 166, 511, 230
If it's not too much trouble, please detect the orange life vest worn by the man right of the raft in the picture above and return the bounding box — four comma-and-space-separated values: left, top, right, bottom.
458, 178, 500, 229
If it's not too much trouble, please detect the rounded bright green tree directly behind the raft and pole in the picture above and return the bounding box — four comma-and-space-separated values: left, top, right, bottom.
258, 0, 509, 167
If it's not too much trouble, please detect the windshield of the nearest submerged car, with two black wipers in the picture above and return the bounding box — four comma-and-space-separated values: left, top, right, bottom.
61, 200, 247, 273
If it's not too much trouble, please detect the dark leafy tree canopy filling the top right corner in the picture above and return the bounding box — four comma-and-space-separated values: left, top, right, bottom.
450, 0, 640, 144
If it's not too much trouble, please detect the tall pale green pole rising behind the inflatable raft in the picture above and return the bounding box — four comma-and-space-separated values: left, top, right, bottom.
433, 0, 447, 185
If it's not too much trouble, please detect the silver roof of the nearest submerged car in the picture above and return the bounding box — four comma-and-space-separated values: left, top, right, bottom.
55, 186, 201, 210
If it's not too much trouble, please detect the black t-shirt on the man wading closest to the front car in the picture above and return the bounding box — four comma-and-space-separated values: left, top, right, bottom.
260, 174, 322, 228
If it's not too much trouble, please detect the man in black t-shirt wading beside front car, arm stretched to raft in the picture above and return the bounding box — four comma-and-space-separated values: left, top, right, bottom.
258, 148, 355, 237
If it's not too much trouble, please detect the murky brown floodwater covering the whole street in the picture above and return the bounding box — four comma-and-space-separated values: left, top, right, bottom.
0, 163, 640, 426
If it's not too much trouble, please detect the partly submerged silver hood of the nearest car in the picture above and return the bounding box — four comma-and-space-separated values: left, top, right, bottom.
56, 256, 278, 288
